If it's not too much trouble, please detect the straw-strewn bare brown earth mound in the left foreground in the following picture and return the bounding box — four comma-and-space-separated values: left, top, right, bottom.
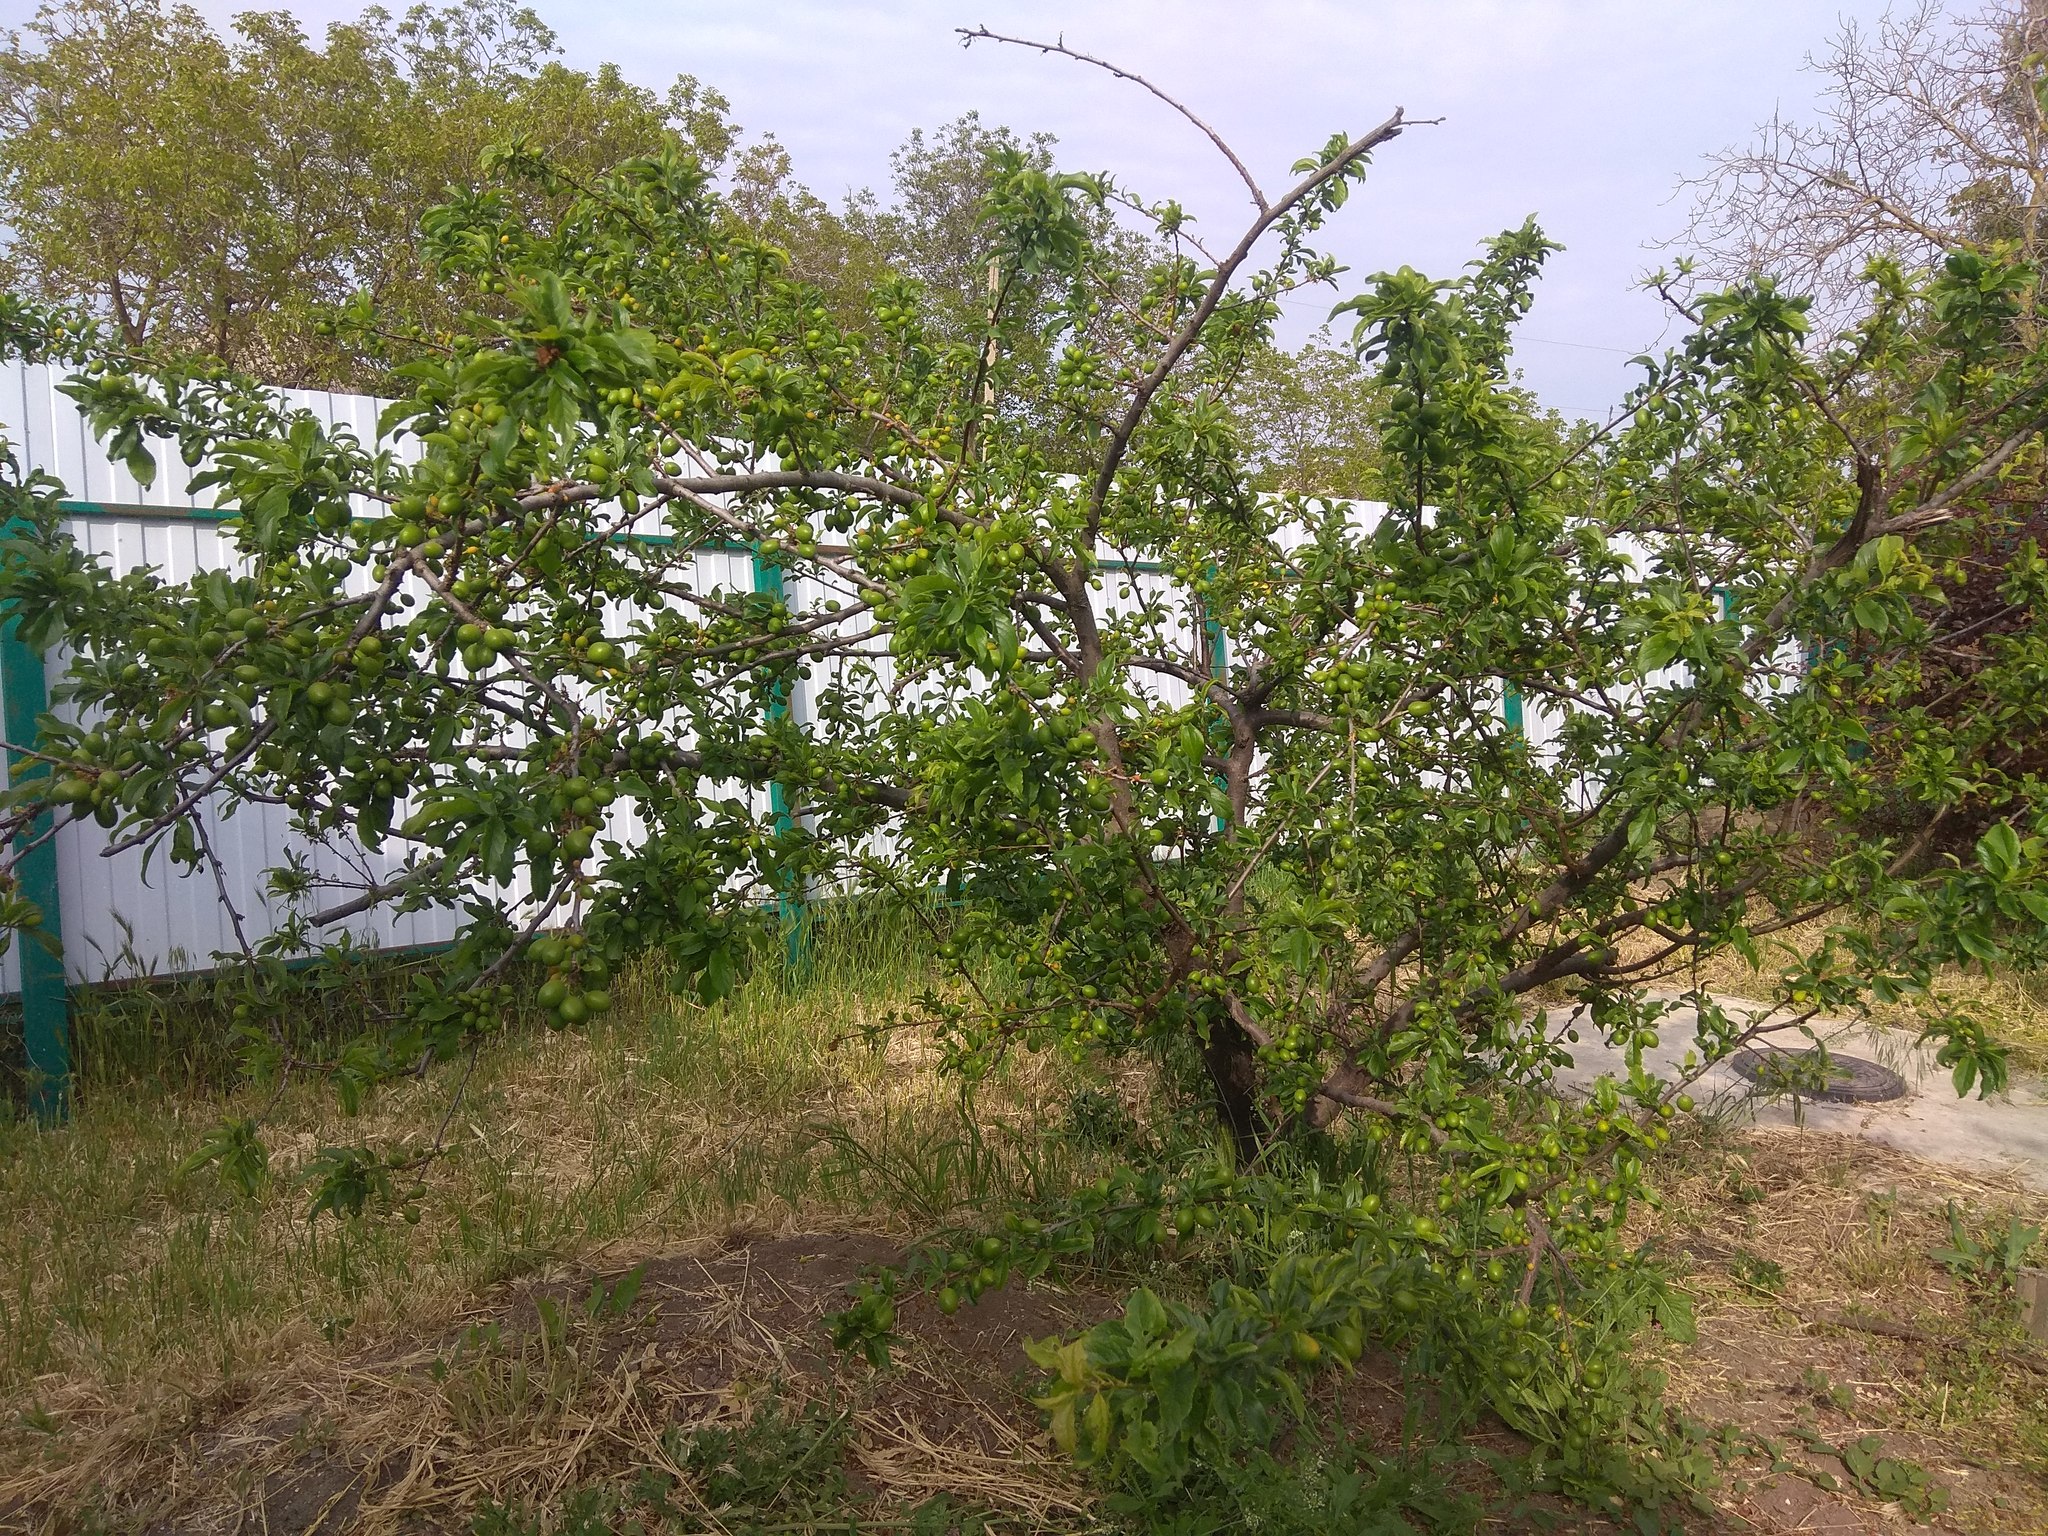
0, 1237, 1087, 1534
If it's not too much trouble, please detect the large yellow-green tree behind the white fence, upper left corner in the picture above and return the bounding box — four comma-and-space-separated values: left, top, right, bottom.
0, 0, 731, 387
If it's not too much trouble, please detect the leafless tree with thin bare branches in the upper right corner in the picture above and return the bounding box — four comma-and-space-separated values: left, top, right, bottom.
1673, 0, 2048, 846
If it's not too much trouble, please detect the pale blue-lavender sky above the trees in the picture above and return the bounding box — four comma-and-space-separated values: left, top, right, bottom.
24, 0, 1884, 414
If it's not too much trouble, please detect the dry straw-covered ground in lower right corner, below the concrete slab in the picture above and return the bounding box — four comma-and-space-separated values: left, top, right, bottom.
1645, 1130, 2048, 1532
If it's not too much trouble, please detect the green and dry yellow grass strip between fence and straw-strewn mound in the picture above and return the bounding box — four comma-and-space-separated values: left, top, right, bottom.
0, 925, 1122, 1528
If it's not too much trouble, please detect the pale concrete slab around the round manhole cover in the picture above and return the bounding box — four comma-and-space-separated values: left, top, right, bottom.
1544, 995, 2048, 1190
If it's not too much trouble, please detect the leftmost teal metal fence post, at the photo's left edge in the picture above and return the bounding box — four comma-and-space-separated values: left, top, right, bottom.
0, 524, 72, 1124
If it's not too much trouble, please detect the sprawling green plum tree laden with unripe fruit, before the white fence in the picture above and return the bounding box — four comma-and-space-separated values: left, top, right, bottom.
0, 54, 2048, 1523
